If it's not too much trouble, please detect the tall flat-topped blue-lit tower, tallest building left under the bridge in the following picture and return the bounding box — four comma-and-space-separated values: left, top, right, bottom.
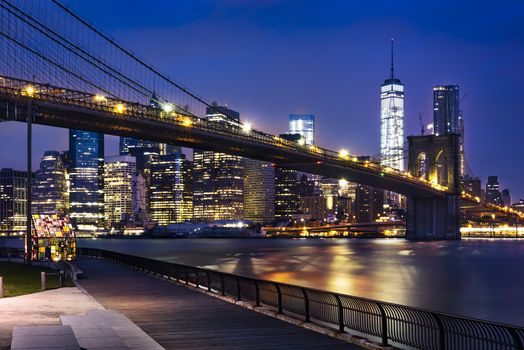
69, 130, 104, 234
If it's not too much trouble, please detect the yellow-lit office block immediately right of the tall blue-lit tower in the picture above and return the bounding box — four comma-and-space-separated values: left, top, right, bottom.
104, 156, 136, 228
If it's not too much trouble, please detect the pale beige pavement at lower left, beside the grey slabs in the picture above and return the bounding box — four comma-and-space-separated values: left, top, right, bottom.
0, 287, 103, 349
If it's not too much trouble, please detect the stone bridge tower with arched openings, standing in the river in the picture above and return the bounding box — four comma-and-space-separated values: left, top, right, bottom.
406, 134, 460, 240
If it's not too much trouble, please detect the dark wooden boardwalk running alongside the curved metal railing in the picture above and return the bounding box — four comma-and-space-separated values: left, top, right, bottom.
77, 258, 362, 350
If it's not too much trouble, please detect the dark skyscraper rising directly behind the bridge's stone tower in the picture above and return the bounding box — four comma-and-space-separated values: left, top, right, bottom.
433, 85, 460, 135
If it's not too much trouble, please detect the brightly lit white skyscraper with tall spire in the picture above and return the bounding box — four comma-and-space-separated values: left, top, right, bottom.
380, 40, 404, 171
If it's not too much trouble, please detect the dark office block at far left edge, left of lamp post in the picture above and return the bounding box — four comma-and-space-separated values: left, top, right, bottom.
0, 169, 27, 235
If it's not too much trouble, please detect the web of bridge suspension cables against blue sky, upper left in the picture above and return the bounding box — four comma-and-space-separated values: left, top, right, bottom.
0, 0, 239, 118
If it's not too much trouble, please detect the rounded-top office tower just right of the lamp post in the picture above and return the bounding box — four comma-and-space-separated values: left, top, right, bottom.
32, 151, 68, 215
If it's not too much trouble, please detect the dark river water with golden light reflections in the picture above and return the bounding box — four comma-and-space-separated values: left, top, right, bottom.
71, 239, 524, 326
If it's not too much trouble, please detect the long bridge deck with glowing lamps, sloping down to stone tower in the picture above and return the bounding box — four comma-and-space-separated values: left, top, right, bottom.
0, 76, 442, 198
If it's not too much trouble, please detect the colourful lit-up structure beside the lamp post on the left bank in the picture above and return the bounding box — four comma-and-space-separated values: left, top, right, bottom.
31, 214, 76, 261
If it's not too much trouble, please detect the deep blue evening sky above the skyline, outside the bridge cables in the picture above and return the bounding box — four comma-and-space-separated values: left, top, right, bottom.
0, 0, 524, 201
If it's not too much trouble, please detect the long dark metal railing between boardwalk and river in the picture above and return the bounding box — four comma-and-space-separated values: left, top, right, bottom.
78, 248, 524, 350
